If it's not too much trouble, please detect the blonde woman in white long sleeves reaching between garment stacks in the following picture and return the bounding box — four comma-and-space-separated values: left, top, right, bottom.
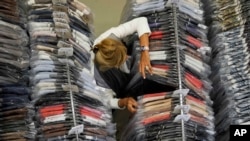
93, 17, 152, 113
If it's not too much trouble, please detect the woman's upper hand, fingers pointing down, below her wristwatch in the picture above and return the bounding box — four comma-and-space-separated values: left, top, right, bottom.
139, 50, 152, 79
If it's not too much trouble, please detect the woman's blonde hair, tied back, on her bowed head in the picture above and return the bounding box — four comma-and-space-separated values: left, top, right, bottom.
94, 38, 127, 71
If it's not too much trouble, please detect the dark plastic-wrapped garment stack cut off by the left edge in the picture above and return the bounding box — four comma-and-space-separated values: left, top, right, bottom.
0, 0, 36, 141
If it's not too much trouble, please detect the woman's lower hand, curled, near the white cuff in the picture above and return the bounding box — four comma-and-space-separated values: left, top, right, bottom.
118, 97, 138, 113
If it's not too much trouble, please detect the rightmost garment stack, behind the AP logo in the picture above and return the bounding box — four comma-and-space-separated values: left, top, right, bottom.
203, 0, 250, 141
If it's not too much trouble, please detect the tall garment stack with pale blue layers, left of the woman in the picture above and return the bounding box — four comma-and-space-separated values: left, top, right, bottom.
27, 0, 115, 141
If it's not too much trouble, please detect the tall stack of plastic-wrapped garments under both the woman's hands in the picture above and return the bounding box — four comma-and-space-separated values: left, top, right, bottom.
119, 0, 215, 141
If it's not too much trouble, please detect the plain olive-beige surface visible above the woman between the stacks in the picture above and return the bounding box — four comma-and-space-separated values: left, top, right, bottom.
80, 0, 126, 36
